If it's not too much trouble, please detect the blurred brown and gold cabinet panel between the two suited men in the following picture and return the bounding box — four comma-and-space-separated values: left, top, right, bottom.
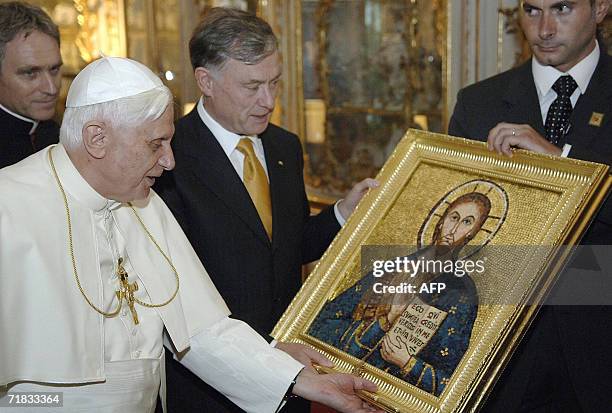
298, 0, 447, 199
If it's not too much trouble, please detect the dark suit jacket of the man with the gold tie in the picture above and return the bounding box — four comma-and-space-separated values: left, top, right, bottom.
155, 109, 340, 412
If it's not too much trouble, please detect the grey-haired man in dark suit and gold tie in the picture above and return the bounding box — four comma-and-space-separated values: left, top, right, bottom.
156, 8, 376, 412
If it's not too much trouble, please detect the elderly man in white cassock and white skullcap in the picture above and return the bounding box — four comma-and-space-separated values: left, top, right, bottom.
0, 57, 376, 412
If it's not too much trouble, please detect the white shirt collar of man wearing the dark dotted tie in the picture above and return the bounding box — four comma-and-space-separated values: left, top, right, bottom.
531, 41, 601, 96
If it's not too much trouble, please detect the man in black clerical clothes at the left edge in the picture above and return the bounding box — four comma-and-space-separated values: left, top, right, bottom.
0, 2, 62, 168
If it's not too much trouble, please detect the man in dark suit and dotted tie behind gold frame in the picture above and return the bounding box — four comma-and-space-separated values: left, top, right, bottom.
449, 0, 612, 412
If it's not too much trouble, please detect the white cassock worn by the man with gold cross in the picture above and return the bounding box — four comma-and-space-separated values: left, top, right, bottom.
0, 145, 303, 412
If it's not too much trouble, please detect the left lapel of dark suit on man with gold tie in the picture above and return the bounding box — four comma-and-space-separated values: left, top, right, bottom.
187, 109, 274, 245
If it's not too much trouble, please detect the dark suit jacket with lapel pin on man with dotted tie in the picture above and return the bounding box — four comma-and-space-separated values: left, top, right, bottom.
448, 50, 612, 244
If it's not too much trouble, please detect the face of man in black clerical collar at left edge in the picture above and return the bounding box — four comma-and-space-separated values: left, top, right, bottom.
0, 30, 62, 121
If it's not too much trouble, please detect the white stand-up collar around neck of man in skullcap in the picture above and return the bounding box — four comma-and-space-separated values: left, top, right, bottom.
49, 143, 121, 212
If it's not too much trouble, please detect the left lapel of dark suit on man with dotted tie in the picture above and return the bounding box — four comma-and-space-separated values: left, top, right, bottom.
503, 60, 546, 136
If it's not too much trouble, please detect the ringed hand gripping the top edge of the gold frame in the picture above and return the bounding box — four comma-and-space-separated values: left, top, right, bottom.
487, 122, 562, 156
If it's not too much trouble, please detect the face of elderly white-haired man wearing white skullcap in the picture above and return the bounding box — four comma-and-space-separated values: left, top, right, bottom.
100, 105, 174, 202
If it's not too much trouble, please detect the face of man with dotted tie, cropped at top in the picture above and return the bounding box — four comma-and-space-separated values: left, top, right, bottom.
520, 0, 608, 72
